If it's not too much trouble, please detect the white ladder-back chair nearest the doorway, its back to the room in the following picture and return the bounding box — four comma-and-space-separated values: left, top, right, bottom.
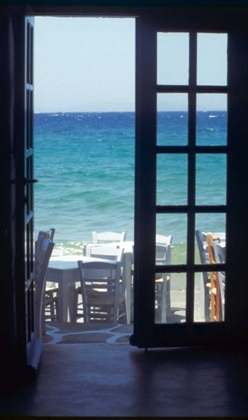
78, 260, 124, 324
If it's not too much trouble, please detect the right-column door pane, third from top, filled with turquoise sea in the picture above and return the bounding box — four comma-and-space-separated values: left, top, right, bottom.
196, 154, 227, 205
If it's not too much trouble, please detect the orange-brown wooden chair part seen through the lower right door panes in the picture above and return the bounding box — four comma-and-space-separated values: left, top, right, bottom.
207, 233, 222, 322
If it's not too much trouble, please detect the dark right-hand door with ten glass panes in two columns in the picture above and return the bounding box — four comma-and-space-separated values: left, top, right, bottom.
131, 13, 228, 347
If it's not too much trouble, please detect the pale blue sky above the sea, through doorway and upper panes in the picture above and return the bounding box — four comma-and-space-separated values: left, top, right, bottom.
34, 17, 227, 112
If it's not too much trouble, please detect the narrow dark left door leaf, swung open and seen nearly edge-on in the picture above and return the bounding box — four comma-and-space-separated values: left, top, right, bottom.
20, 11, 42, 370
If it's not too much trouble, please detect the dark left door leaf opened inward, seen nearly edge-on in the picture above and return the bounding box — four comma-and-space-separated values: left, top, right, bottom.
16, 10, 39, 370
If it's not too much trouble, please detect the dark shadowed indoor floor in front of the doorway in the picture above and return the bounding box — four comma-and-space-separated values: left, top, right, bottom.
0, 343, 248, 418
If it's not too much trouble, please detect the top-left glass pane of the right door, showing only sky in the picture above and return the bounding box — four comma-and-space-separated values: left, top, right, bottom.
157, 32, 189, 85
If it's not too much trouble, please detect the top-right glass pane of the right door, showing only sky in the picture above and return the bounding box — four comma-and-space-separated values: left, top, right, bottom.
197, 33, 227, 86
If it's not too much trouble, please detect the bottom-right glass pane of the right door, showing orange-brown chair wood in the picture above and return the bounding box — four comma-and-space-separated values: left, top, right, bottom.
194, 271, 225, 322
